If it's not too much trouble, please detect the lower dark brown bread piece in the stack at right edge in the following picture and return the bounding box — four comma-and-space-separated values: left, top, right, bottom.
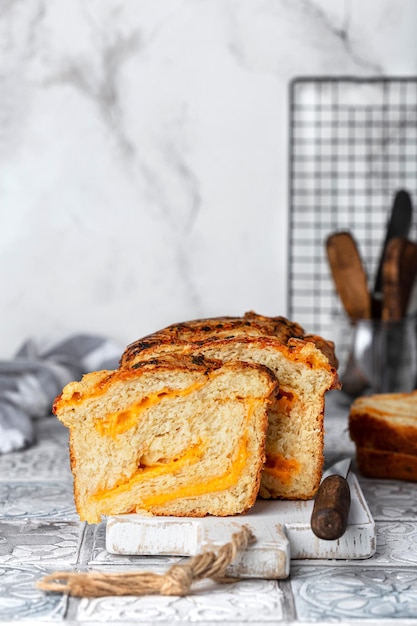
356, 447, 417, 482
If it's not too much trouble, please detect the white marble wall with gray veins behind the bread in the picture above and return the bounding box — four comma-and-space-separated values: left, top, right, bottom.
0, 0, 417, 358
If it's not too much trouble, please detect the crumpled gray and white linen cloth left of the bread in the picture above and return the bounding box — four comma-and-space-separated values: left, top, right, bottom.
0, 335, 122, 453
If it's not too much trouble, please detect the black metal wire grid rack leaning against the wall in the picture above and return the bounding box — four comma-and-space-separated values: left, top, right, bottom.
288, 77, 417, 358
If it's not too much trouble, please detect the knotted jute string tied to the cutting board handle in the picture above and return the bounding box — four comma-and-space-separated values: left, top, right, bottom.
37, 526, 255, 598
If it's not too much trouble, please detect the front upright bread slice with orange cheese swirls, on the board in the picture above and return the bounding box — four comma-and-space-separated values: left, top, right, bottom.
53, 355, 277, 523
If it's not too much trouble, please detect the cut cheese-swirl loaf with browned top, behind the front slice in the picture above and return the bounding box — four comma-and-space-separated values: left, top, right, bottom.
121, 312, 340, 499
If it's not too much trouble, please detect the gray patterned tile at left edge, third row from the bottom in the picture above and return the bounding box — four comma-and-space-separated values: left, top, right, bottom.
0, 482, 79, 521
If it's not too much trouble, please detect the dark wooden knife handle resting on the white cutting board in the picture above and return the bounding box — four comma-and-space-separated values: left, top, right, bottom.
311, 474, 350, 540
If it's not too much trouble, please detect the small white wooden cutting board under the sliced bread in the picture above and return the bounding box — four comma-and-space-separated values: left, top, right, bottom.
106, 473, 376, 579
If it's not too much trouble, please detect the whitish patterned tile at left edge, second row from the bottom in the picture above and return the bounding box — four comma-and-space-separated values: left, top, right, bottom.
0, 521, 84, 567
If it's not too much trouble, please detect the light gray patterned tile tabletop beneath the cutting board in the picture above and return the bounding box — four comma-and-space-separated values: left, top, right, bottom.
0, 394, 417, 626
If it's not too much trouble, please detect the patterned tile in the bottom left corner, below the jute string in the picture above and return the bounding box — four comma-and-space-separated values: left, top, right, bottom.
0, 565, 67, 623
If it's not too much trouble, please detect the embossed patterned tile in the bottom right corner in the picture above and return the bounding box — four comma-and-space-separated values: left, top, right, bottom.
291, 566, 417, 622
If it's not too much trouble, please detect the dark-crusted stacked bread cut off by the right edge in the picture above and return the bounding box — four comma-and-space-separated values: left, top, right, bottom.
349, 391, 417, 481
